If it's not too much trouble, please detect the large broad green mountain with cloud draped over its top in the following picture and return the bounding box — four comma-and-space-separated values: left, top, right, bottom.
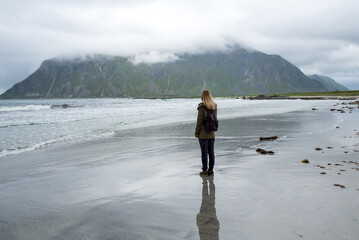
1, 47, 328, 98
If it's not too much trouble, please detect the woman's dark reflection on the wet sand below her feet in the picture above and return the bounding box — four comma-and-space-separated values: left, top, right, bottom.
197, 176, 219, 240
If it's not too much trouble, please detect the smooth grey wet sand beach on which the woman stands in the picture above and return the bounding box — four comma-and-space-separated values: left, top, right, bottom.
0, 101, 359, 239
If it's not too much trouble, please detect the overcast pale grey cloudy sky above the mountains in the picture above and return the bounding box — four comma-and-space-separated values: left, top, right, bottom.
0, 0, 359, 94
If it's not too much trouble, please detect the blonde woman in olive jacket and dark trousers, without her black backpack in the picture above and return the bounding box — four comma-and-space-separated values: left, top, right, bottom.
195, 90, 217, 176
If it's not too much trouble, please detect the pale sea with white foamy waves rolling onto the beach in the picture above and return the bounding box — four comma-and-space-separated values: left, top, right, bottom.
0, 99, 332, 158
